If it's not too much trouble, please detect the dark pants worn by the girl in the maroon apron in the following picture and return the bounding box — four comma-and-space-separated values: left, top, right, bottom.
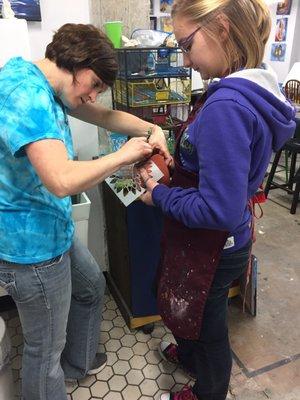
175, 243, 251, 400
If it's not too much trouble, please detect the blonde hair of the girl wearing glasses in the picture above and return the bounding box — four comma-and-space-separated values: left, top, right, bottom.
172, 0, 271, 73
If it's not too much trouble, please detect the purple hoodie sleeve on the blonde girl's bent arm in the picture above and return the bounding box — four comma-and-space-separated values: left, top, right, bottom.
152, 100, 256, 231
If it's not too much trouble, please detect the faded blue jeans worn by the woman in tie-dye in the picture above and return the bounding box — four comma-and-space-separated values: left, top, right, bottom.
0, 239, 105, 400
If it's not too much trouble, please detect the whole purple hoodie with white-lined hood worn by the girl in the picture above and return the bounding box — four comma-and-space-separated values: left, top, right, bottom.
152, 65, 295, 252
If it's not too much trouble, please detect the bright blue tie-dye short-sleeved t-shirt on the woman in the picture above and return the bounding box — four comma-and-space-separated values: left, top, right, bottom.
0, 57, 74, 264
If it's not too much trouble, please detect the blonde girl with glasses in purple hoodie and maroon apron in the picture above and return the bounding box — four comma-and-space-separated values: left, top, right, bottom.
142, 0, 295, 400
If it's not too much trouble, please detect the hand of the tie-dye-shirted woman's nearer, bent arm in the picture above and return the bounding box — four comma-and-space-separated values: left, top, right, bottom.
116, 137, 153, 165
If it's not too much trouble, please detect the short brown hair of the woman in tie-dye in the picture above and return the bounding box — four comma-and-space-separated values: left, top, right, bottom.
45, 24, 118, 86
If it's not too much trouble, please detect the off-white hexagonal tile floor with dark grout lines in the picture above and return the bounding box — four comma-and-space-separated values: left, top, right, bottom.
1, 294, 202, 400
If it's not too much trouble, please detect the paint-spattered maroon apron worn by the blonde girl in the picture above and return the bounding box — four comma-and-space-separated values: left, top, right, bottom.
158, 94, 228, 339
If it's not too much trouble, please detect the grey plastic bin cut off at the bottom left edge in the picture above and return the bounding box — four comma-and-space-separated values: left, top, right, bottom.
0, 317, 14, 400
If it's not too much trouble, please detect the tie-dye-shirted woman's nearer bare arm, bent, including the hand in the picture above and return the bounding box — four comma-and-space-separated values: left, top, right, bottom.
26, 138, 152, 197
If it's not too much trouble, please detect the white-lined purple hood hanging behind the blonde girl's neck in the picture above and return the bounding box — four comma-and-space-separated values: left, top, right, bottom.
208, 64, 295, 152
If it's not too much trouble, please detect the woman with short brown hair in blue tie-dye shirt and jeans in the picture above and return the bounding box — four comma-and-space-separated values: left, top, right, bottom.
0, 24, 169, 400
